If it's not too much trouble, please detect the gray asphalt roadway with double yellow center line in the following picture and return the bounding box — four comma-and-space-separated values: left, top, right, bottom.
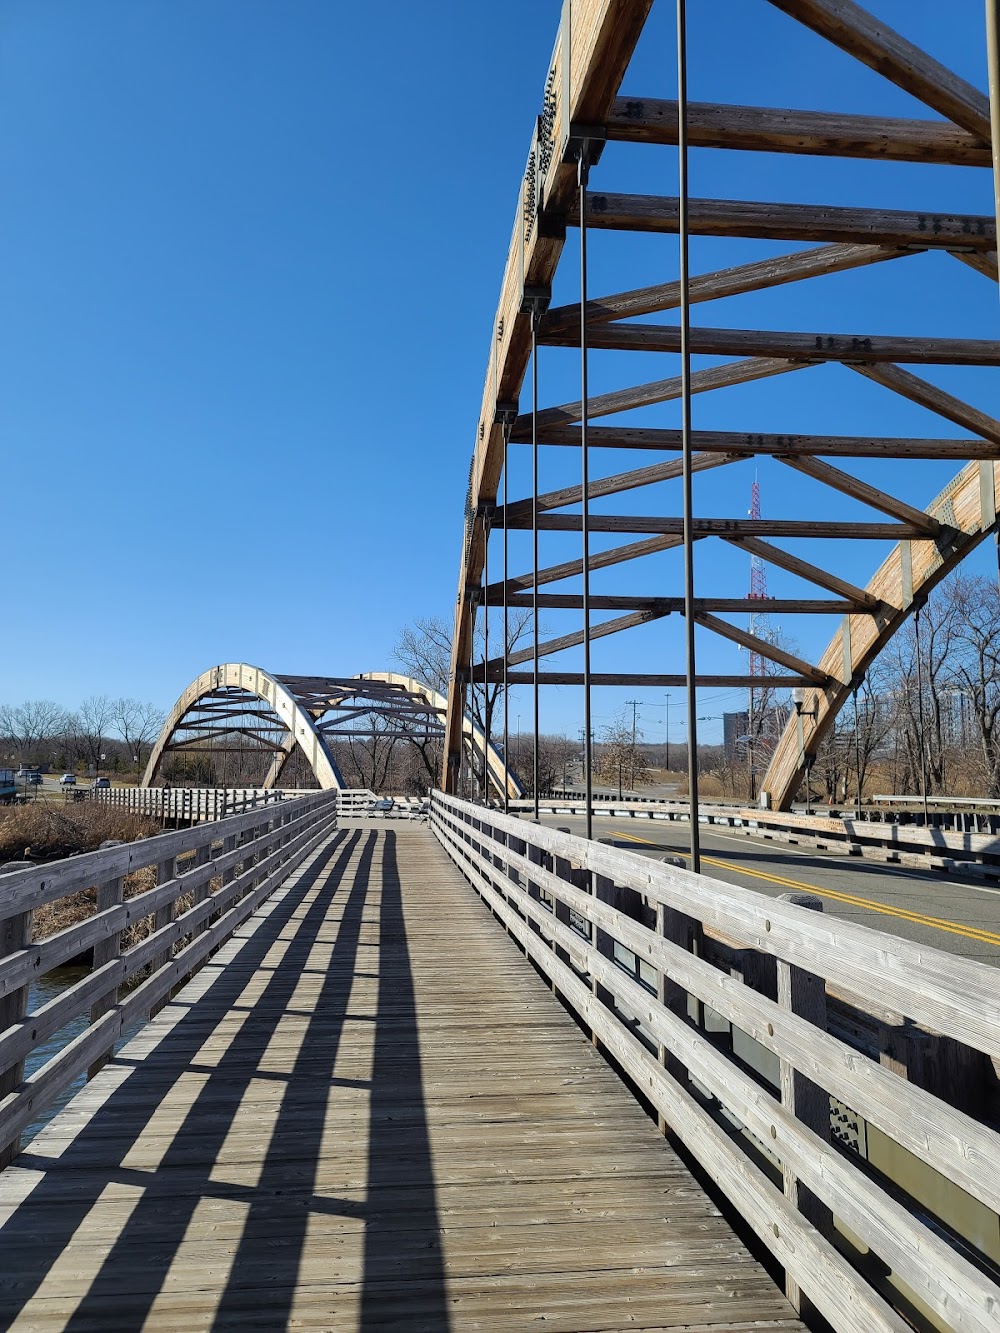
541, 813, 1000, 966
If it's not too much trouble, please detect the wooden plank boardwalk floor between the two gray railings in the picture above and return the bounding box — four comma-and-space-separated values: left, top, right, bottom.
0, 826, 801, 1333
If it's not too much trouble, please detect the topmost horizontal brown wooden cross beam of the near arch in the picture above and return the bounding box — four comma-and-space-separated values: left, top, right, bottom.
608, 97, 992, 167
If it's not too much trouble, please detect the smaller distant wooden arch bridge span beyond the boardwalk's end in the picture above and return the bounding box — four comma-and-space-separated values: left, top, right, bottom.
143, 663, 521, 797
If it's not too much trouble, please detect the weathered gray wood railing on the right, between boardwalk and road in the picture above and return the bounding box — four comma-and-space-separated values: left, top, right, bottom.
431, 794, 1000, 1333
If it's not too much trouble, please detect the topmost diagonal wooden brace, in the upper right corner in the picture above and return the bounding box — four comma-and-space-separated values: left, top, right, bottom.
771, 0, 989, 143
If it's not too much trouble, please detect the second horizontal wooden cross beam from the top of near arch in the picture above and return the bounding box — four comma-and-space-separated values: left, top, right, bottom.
576, 193, 996, 252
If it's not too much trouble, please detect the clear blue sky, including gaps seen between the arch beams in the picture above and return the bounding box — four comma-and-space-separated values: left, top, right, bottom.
0, 0, 1000, 736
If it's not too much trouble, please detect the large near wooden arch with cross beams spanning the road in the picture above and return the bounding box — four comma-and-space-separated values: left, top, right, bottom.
443, 0, 1000, 809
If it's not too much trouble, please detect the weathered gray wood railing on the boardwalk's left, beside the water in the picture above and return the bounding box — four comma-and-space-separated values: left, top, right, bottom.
0, 792, 336, 1166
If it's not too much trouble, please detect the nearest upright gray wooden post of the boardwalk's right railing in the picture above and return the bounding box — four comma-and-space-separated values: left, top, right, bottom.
777, 893, 832, 1314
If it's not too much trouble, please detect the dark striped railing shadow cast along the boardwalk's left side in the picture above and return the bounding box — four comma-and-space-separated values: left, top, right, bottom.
0, 830, 448, 1333
